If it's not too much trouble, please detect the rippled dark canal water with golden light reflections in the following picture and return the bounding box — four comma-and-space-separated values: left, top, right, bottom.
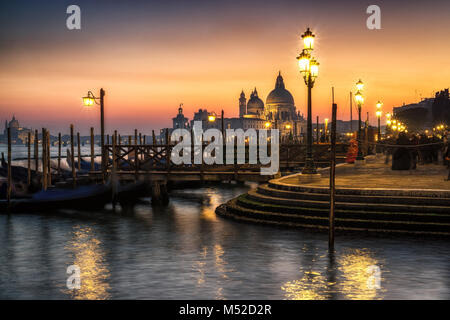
0, 144, 450, 299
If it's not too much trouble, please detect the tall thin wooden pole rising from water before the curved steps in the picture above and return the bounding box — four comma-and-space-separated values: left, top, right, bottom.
328, 88, 337, 250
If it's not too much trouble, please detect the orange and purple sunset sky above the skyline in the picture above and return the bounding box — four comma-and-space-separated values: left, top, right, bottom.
0, 0, 450, 135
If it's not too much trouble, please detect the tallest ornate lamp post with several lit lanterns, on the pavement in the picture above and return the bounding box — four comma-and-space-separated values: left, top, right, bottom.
297, 28, 319, 174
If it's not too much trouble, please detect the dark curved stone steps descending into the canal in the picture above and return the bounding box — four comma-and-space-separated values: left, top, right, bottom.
217, 181, 450, 236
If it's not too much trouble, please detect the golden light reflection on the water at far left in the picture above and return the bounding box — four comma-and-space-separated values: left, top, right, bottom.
67, 226, 110, 300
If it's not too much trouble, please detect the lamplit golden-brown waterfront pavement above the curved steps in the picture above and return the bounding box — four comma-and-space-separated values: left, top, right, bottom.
279, 156, 450, 190
